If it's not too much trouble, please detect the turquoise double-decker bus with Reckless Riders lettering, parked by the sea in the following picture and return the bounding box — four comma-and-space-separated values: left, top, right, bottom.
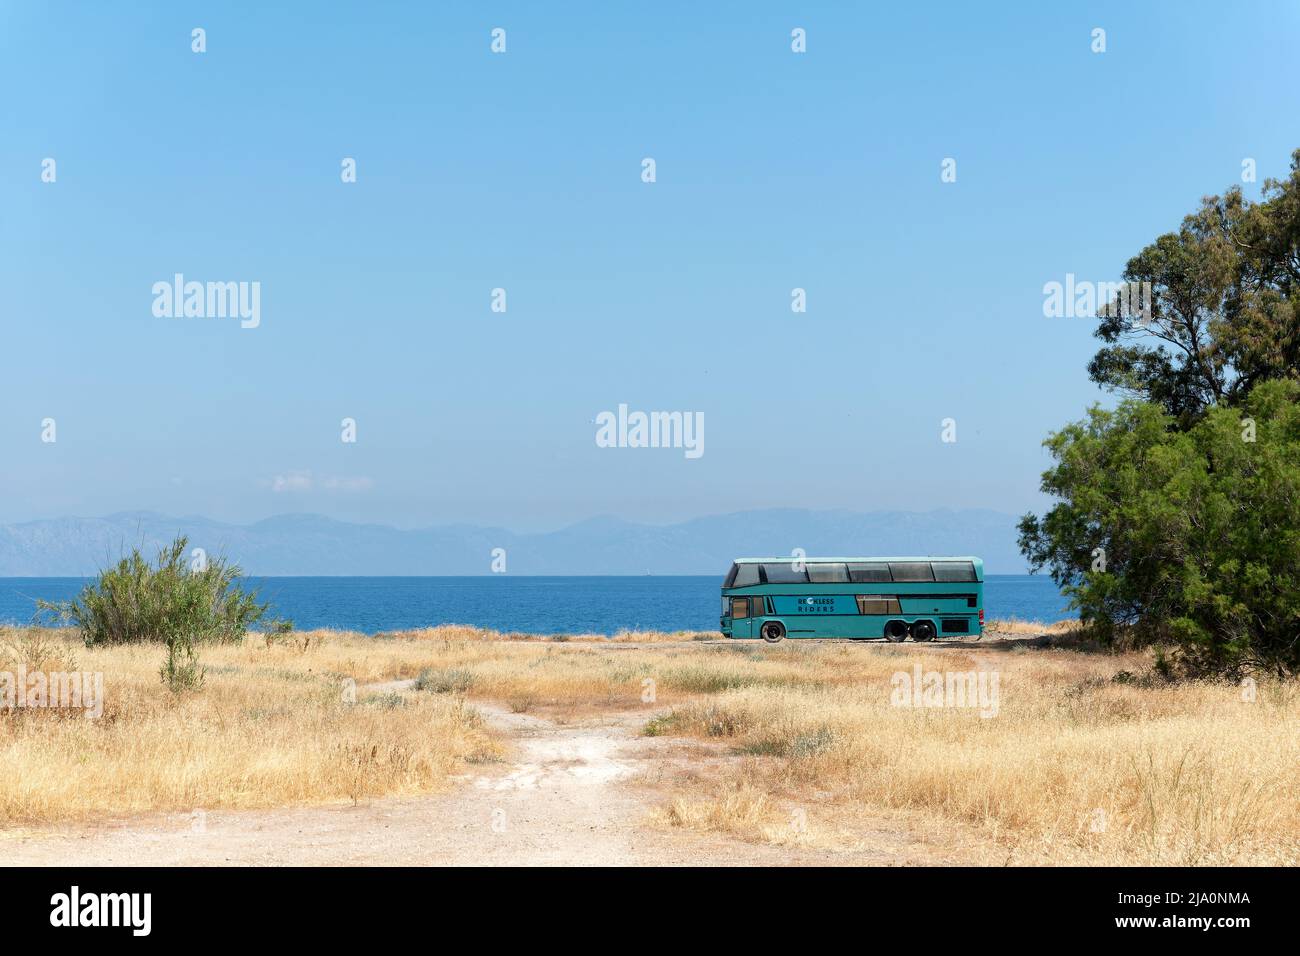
722, 557, 984, 644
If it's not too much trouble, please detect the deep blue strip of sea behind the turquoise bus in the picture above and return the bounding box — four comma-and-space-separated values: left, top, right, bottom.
0, 575, 1074, 636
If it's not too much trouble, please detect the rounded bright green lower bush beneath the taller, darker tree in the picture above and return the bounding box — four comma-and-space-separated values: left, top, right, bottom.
1021, 380, 1300, 676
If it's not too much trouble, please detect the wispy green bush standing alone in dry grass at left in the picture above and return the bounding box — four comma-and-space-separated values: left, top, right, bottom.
38, 537, 268, 647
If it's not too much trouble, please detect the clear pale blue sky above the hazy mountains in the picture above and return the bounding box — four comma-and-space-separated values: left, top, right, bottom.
0, 3, 1300, 531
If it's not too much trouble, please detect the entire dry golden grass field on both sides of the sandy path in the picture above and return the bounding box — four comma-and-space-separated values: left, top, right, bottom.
0, 624, 1300, 864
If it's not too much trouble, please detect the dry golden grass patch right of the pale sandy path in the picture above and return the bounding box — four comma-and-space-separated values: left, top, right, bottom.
639, 645, 1300, 865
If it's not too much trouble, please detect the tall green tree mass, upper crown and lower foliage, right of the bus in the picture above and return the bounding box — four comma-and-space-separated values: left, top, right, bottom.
1019, 150, 1300, 674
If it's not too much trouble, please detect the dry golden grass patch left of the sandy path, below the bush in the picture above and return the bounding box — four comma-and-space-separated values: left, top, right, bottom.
0, 631, 497, 825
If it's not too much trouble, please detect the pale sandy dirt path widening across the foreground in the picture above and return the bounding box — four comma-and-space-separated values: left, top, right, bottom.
0, 682, 920, 866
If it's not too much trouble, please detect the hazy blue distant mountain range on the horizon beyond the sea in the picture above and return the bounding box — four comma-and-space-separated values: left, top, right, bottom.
0, 509, 1024, 578
